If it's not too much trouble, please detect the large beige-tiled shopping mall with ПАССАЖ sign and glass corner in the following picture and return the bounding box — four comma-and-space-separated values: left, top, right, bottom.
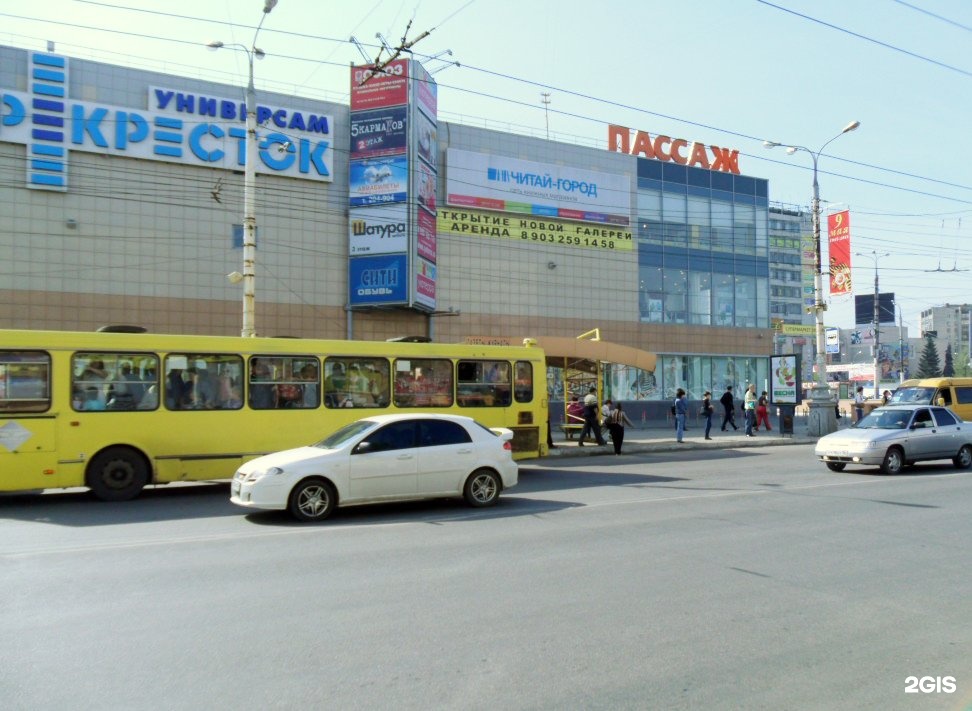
0, 47, 801, 400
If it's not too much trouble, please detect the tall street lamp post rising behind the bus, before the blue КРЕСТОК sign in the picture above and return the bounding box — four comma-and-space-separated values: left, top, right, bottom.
206, 0, 278, 337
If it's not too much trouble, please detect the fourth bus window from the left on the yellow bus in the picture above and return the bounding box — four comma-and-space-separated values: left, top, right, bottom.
248, 356, 320, 410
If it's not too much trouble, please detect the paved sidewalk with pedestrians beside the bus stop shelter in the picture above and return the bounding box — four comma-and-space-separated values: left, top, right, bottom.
547, 417, 824, 458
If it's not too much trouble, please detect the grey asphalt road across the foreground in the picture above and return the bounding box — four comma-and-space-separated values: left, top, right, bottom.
0, 446, 972, 711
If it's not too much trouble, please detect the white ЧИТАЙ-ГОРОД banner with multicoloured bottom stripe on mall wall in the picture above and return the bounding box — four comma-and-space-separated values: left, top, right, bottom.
446, 148, 631, 226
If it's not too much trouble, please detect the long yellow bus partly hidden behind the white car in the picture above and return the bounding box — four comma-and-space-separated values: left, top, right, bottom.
0, 330, 548, 501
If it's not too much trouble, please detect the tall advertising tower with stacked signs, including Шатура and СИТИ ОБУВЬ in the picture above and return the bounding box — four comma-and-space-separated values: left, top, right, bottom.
348, 59, 439, 311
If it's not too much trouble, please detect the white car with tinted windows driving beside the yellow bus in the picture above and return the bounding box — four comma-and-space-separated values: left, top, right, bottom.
230, 414, 519, 521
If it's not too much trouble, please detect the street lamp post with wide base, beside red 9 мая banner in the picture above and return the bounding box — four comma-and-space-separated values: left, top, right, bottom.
763, 121, 861, 437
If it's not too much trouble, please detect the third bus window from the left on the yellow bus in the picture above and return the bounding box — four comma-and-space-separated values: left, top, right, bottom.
165, 353, 243, 410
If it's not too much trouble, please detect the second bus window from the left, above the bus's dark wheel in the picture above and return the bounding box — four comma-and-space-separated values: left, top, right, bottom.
71, 351, 159, 411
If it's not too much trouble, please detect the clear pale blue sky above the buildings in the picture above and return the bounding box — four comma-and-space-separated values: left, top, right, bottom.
0, 0, 972, 336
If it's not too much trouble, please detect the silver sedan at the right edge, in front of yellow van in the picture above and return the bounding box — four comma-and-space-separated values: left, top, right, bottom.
814, 405, 972, 474
